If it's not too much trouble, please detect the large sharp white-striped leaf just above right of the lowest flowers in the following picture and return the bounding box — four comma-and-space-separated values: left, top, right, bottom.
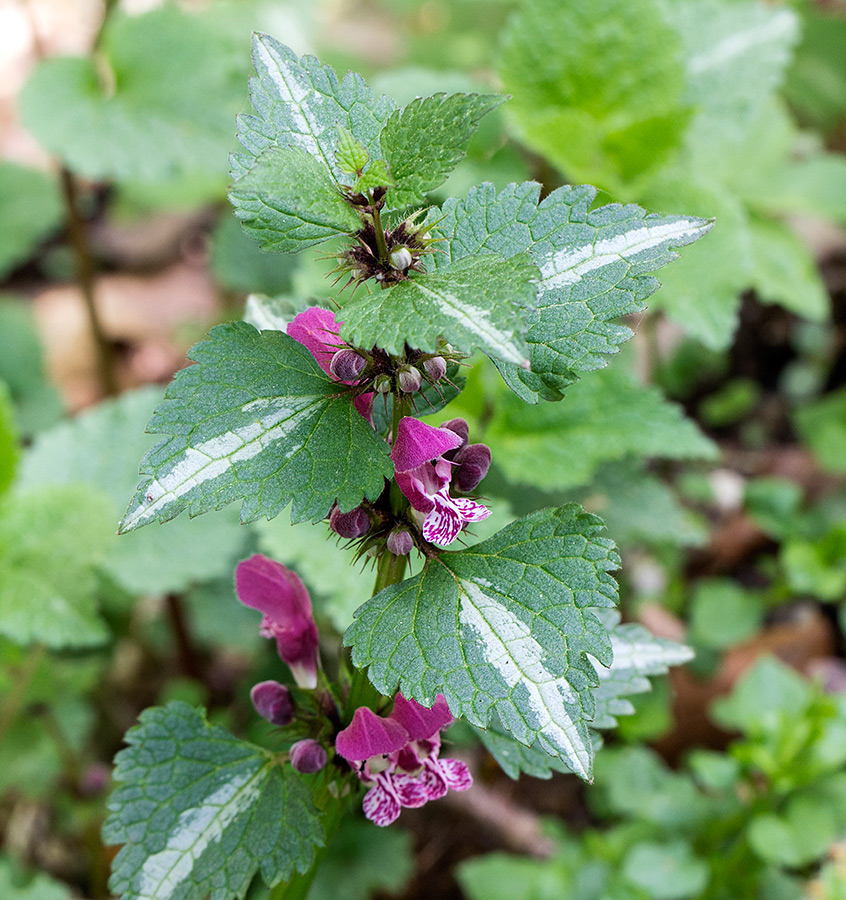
345, 504, 619, 778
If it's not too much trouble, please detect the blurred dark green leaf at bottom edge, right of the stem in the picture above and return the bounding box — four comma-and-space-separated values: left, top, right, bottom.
308, 817, 414, 900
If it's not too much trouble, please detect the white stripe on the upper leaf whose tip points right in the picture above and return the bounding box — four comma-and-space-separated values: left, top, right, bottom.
540, 219, 710, 291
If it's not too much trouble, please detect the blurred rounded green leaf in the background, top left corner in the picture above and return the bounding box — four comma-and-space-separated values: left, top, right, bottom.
21, 4, 247, 181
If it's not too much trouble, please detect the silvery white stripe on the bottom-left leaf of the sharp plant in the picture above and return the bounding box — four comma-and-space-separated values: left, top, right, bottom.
134, 766, 264, 900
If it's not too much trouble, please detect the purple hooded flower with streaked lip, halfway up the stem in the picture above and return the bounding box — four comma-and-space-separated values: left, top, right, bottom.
391, 416, 491, 545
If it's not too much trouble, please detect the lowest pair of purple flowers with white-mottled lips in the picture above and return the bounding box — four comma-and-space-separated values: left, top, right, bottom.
335, 694, 473, 825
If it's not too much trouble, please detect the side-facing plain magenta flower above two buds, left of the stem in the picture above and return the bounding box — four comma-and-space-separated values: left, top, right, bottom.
235, 553, 318, 688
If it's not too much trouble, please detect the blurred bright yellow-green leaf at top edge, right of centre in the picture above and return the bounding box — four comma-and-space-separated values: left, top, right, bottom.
500, 0, 689, 193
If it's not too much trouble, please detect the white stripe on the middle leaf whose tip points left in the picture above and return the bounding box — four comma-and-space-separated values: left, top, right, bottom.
121, 397, 316, 531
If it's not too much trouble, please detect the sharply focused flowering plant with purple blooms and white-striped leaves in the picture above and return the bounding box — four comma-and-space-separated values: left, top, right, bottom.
105, 35, 710, 900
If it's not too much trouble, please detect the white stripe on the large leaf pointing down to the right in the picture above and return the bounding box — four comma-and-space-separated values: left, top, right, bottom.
459, 579, 591, 778
